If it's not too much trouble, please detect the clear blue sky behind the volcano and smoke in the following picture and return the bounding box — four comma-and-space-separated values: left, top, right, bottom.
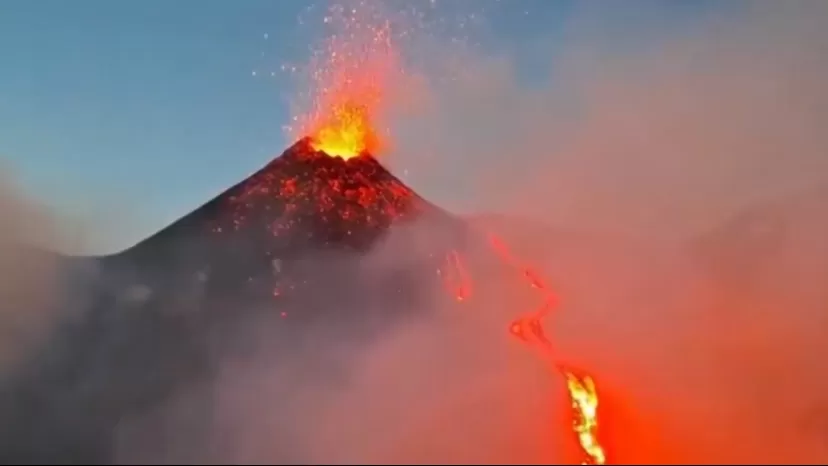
0, 0, 716, 250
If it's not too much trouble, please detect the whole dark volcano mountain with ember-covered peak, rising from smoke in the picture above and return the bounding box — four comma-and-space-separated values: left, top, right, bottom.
0, 140, 466, 464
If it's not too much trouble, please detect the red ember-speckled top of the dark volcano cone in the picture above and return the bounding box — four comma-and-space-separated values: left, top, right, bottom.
219, 139, 426, 249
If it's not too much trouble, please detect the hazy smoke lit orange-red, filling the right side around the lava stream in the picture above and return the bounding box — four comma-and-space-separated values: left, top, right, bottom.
6, 1, 828, 464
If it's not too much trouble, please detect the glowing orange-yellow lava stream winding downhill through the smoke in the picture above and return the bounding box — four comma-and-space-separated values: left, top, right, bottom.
447, 235, 607, 464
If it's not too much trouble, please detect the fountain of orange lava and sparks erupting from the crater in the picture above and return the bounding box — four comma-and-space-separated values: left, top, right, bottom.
288, 3, 404, 160
